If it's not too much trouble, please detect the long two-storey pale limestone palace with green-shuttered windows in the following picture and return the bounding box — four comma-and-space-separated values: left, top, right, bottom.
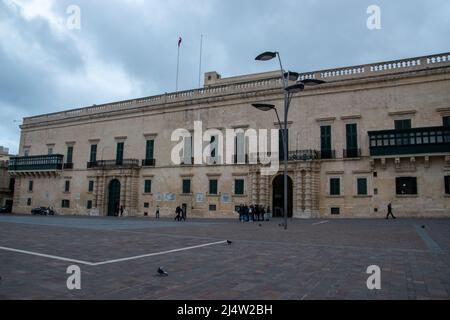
8, 53, 450, 218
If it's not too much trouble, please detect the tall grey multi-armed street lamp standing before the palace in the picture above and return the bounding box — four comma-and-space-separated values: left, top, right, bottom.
252, 51, 325, 230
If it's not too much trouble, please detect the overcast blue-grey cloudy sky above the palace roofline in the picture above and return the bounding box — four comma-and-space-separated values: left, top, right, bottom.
0, 0, 450, 153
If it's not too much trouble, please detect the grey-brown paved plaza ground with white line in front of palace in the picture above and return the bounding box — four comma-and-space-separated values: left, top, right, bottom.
0, 215, 450, 300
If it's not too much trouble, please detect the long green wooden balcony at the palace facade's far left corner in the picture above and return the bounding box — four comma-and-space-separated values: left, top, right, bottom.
8, 154, 64, 171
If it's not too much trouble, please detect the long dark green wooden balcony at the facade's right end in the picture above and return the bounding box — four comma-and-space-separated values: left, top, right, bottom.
369, 127, 450, 156
